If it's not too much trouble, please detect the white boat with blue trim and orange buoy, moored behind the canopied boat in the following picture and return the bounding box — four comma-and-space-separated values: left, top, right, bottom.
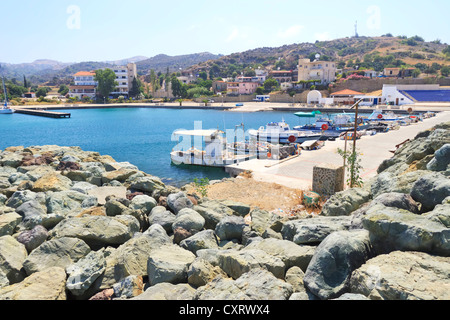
248, 121, 322, 144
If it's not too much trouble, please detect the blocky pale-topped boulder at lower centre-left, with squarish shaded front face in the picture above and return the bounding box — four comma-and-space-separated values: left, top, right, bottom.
147, 245, 195, 285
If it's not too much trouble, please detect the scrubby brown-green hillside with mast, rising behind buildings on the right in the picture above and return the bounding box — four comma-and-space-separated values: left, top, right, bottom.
187, 36, 450, 77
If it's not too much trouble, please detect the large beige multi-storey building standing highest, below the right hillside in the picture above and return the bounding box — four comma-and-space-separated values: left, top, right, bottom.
298, 59, 337, 84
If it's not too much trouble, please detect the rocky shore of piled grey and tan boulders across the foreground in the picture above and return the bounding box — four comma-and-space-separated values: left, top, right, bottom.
0, 123, 450, 300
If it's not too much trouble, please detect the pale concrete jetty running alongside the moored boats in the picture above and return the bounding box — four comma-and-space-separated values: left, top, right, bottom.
225, 111, 450, 190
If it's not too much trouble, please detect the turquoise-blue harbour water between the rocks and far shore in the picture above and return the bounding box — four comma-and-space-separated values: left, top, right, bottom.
0, 108, 326, 185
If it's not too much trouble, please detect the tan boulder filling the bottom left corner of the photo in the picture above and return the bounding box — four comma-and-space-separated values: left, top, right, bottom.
0, 267, 67, 301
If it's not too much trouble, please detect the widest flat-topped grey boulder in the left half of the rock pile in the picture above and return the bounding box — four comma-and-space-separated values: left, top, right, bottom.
50, 215, 139, 248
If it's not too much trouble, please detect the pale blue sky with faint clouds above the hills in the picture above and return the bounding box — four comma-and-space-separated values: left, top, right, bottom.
0, 0, 450, 63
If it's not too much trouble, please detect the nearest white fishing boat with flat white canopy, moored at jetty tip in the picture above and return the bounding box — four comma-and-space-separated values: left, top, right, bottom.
170, 130, 255, 167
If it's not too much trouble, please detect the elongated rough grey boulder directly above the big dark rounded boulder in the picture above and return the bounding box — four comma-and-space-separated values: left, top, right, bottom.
281, 216, 351, 245
